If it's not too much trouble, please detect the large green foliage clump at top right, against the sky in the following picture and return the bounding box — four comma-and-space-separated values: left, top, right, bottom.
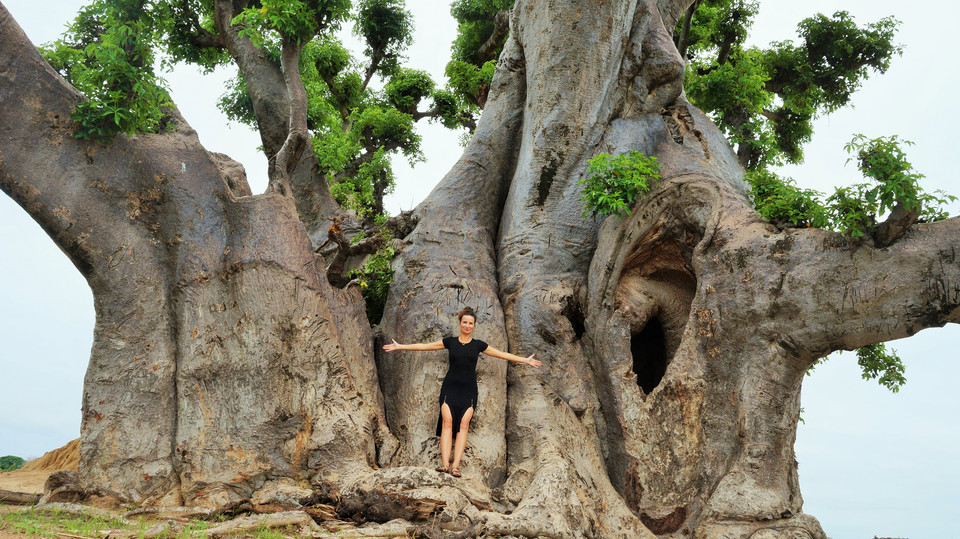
675, 0, 901, 170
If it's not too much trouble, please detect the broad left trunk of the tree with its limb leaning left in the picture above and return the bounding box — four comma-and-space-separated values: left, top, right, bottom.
0, 3, 392, 505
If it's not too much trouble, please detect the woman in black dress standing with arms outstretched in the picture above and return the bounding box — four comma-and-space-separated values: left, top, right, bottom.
383, 307, 541, 477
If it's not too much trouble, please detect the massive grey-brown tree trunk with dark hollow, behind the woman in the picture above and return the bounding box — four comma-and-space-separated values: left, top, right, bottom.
0, 0, 960, 537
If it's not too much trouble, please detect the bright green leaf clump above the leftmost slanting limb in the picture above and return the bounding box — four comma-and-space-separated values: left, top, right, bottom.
41, 0, 171, 142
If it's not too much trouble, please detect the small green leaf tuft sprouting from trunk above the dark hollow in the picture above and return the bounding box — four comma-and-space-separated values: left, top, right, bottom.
577, 151, 660, 217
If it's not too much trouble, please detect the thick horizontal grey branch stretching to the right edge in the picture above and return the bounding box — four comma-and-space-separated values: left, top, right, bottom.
721, 217, 960, 364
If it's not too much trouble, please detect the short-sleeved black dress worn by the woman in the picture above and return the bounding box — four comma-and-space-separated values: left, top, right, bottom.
437, 337, 487, 438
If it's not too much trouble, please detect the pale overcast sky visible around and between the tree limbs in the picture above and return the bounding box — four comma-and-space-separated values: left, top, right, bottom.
0, 0, 960, 539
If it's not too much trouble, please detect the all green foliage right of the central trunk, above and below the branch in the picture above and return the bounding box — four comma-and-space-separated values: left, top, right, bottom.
674, 0, 956, 392
